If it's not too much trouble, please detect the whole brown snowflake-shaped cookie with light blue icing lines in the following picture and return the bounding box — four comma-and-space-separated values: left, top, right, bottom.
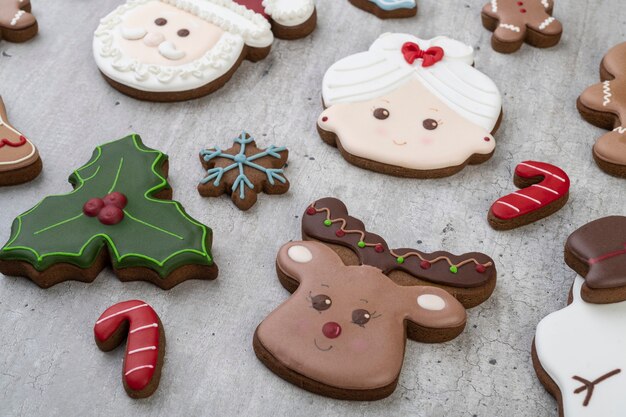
198, 132, 289, 210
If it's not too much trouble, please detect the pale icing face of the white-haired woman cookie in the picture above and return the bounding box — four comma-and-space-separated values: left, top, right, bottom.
318, 79, 495, 170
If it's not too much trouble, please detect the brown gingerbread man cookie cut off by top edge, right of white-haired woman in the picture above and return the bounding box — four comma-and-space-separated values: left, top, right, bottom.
481, 0, 563, 54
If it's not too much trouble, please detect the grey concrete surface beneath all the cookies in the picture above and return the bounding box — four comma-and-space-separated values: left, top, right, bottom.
0, 0, 626, 417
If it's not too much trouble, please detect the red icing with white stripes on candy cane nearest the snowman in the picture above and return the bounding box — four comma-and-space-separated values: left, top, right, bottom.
491, 161, 570, 220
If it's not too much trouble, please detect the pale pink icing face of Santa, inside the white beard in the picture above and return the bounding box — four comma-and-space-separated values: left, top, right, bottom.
117, 0, 224, 66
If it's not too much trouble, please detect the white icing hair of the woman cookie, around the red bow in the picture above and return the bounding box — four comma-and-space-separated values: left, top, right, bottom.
322, 33, 502, 131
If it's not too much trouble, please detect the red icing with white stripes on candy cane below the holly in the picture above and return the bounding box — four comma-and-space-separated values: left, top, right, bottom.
94, 300, 159, 391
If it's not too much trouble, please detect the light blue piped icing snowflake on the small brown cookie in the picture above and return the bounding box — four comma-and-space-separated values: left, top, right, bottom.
200, 131, 287, 200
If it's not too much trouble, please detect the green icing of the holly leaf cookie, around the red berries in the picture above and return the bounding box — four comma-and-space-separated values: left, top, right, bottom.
0, 135, 213, 277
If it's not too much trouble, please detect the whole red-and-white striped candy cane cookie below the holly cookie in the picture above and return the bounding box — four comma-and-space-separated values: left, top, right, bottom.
93, 300, 165, 398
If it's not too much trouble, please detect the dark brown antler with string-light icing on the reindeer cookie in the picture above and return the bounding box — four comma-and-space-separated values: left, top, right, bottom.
302, 198, 497, 308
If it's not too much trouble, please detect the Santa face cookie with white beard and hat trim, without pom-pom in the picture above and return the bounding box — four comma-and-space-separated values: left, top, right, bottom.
93, 0, 274, 101
